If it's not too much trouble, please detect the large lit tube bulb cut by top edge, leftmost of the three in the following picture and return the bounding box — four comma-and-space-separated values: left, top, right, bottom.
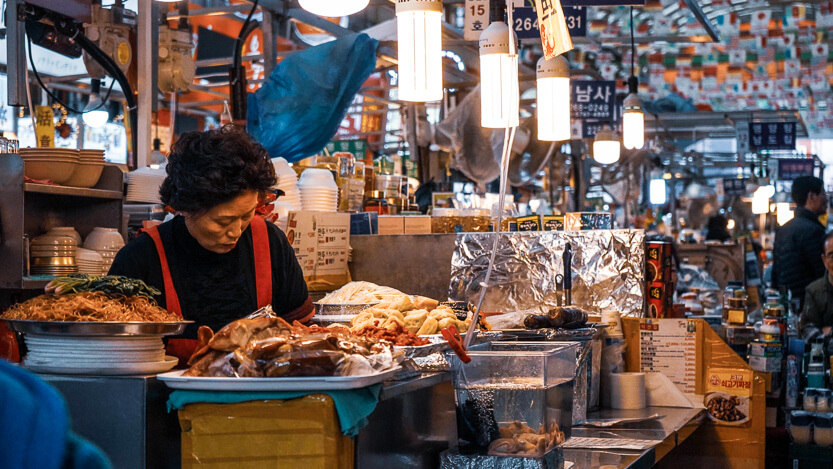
396, 0, 443, 102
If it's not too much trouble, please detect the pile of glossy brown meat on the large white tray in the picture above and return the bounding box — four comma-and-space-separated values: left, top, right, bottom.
183, 317, 397, 378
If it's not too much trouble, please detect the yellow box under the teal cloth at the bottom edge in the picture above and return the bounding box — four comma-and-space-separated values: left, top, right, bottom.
179, 394, 354, 469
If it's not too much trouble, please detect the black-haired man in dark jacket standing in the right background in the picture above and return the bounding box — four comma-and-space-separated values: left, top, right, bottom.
772, 176, 827, 311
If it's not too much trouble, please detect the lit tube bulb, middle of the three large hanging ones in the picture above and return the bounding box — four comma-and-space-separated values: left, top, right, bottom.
480, 21, 520, 129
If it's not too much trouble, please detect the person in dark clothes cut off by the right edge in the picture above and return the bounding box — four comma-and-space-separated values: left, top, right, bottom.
799, 231, 833, 343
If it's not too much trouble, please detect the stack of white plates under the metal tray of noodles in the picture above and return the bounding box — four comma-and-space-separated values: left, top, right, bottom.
23, 334, 177, 375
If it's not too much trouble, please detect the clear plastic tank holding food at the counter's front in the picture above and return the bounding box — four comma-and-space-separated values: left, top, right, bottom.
449, 342, 579, 457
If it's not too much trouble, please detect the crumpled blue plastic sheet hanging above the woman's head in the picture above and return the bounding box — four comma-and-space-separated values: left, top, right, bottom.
247, 33, 379, 162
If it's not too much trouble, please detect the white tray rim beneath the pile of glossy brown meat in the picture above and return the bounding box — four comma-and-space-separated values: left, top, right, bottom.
157, 366, 402, 391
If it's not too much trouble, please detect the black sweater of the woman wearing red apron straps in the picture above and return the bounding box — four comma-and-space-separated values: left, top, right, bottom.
110, 217, 312, 339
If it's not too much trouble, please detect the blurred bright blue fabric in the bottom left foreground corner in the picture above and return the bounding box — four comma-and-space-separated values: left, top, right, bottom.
0, 360, 110, 469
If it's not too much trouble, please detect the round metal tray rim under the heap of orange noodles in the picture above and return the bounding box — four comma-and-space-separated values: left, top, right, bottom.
3, 319, 194, 336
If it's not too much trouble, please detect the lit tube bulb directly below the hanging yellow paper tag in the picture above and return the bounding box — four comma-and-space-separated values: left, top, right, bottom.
536, 55, 570, 142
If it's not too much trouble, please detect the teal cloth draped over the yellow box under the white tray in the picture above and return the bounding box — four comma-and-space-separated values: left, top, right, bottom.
168, 383, 382, 437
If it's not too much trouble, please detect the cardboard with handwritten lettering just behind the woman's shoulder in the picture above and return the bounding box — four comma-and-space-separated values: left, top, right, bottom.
286, 212, 350, 291
